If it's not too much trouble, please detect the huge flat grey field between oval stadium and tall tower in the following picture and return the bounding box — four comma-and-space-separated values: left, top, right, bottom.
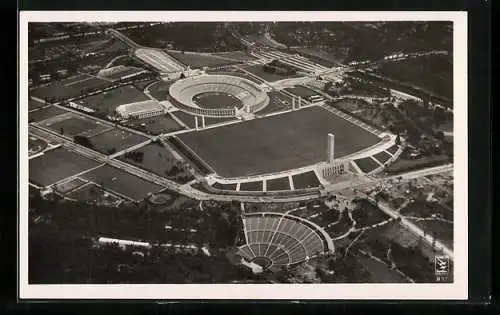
179, 107, 380, 177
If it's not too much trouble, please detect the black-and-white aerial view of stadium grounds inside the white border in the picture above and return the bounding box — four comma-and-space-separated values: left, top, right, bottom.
27, 21, 453, 284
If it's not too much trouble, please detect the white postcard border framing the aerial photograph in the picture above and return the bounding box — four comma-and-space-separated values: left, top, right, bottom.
18, 11, 468, 300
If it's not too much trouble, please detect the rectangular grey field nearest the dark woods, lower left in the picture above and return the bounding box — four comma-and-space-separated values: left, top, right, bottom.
80, 165, 163, 200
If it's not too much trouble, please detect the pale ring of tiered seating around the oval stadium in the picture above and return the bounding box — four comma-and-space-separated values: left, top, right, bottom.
169, 75, 269, 117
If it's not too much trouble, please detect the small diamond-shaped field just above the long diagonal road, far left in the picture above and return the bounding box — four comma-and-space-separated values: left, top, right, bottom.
42, 113, 113, 137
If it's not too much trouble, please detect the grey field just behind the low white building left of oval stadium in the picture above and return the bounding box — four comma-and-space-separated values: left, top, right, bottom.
76, 85, 149, 114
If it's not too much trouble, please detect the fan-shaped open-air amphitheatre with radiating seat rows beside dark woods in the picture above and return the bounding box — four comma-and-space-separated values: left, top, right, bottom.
237, 212, 333, 271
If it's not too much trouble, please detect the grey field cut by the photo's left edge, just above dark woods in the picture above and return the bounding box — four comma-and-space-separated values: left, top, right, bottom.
29, 148, 99, 186
